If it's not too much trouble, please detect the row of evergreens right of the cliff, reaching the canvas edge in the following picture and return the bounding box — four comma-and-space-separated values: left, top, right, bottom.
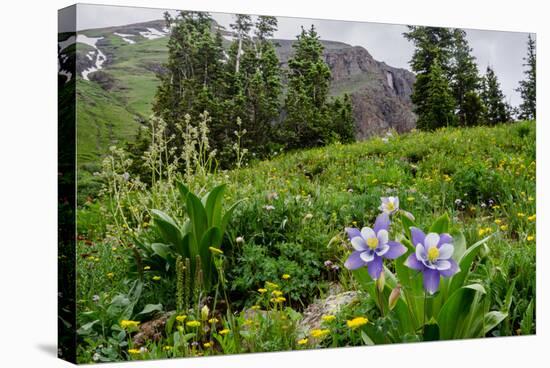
403, 26, 536, 130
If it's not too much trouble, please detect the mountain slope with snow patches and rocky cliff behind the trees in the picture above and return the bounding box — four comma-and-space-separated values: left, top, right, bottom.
59, 20, 416, 164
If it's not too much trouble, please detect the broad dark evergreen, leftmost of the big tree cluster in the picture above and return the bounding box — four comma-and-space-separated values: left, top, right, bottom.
153, 11, 231, 164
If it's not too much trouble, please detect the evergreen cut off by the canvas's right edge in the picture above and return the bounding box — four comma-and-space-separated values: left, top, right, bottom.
517, 35, 537, 119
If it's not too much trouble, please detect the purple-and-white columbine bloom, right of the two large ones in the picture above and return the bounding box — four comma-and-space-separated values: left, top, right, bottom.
405, 227, 460, 294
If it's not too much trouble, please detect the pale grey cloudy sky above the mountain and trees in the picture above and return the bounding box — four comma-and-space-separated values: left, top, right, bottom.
60, 4, 528, 105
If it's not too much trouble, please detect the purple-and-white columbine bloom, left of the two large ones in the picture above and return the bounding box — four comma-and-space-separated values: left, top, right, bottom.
344, 213, 407, 280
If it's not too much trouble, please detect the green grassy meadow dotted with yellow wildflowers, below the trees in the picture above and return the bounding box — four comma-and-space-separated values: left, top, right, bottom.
77, 122, 536, 362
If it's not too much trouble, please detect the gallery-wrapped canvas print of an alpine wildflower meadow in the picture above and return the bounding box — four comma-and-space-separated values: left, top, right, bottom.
57, 4, 536, 364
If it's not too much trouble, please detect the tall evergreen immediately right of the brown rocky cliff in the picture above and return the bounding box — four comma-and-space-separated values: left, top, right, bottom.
403, 26, 454, 129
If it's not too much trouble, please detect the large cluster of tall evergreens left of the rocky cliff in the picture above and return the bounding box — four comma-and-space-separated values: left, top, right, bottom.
153, 11, 355, 167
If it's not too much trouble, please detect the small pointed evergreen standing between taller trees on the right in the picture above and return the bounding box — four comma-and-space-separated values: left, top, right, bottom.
481, 66, 510, 125
